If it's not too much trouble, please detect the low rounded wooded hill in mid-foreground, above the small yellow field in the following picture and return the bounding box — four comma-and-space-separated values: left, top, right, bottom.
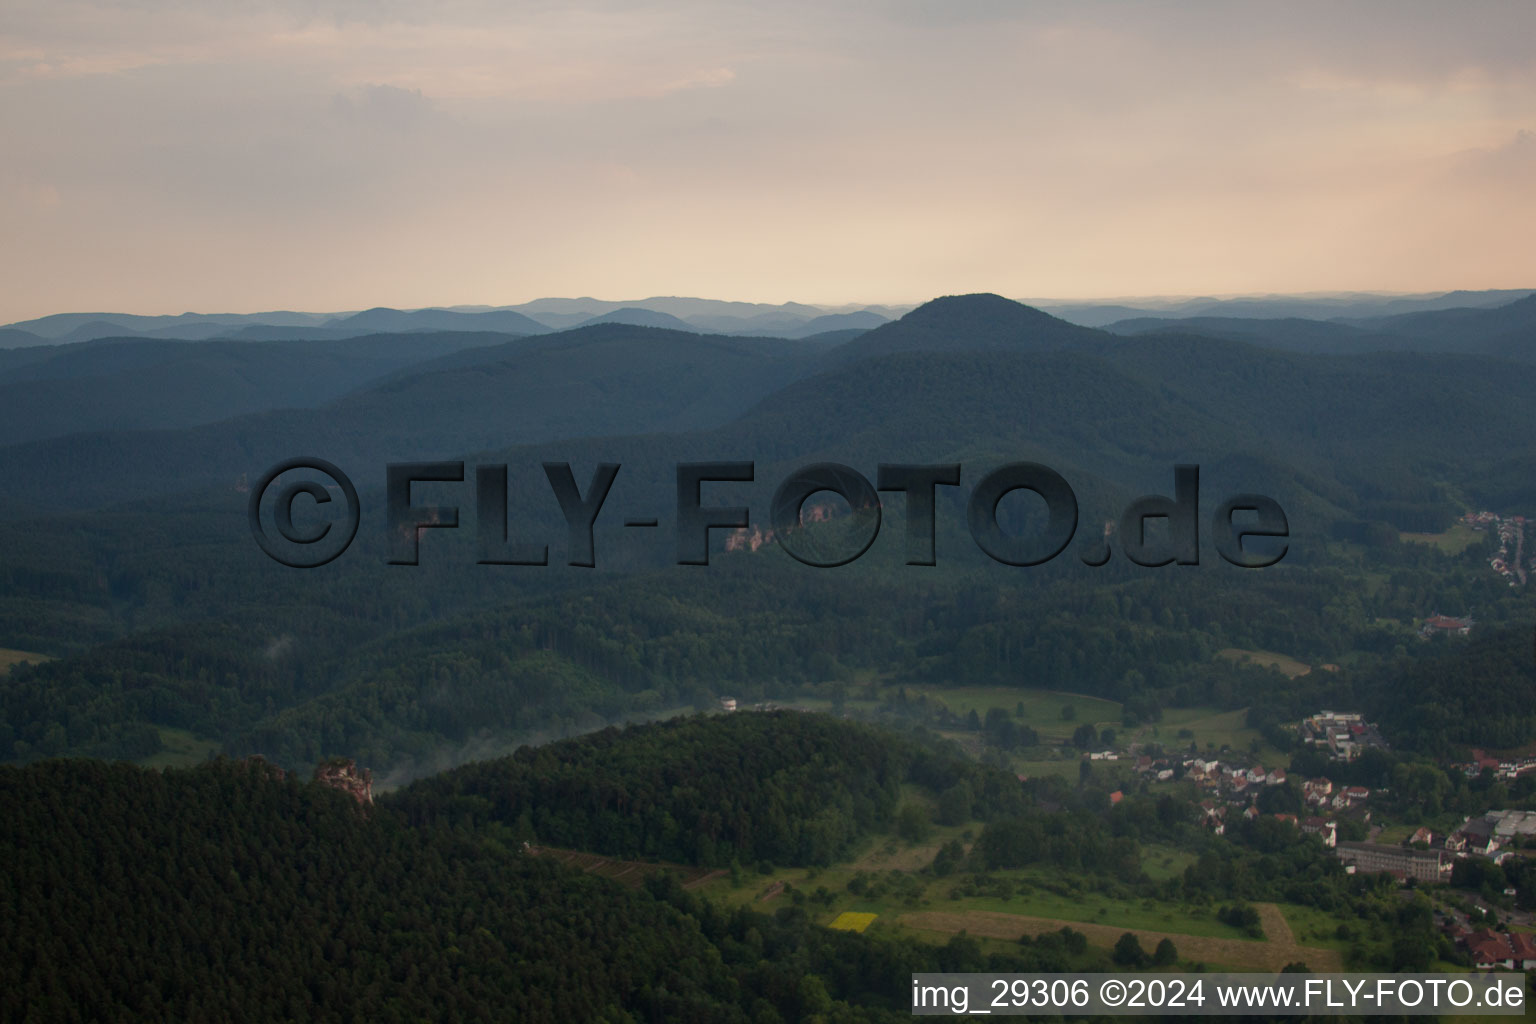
392, 711, 1021, 866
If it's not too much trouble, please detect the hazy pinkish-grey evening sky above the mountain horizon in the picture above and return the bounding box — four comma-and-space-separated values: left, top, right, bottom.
0, 0, 1536, 321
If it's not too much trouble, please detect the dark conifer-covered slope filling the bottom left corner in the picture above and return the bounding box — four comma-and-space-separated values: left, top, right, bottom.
0, 761, 745, 1022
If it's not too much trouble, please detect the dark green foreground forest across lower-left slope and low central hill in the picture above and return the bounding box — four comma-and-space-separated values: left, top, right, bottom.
0, 712, 1462, 1024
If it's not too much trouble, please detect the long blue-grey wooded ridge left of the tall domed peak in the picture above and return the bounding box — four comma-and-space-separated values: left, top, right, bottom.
0, 324, 822, 505
